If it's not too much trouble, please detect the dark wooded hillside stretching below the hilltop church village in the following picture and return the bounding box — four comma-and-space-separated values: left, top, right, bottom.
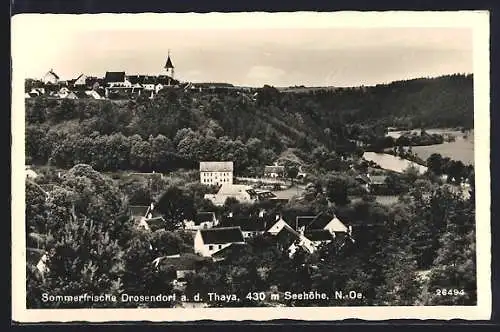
26, 75, 473, 170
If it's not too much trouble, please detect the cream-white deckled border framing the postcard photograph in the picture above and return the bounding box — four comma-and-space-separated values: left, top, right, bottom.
11, 11, 491, 322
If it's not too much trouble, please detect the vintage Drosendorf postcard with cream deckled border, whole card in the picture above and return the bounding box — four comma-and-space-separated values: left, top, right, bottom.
12, 11, 491, 322
